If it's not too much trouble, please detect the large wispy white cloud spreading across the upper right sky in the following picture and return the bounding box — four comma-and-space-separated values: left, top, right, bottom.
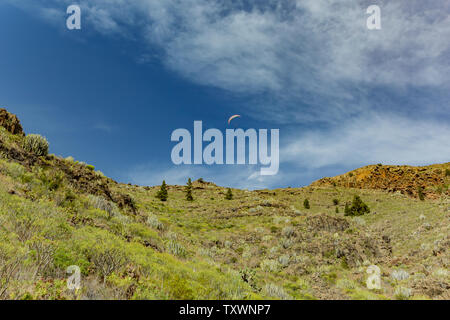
9, 0, 450, 122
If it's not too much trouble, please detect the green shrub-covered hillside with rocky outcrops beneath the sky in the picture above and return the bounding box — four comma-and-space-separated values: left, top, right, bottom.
0, 110, 450, 299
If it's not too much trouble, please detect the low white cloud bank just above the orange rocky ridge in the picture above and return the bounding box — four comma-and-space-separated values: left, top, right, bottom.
280, 114, 450, 168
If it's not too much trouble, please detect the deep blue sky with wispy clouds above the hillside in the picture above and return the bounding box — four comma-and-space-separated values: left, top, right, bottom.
0, 0, 450, 189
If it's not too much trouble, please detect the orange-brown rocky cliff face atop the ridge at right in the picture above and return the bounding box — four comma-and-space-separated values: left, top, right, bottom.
312, 162, 450, 199
